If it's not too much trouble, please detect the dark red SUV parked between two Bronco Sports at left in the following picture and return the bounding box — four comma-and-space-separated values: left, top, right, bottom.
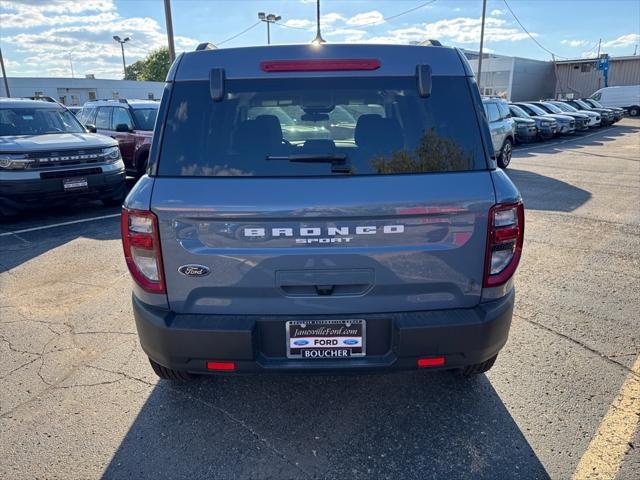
78, 99, 160, 176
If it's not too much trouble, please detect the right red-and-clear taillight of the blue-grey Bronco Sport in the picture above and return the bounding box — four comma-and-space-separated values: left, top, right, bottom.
484, 202, 524, 287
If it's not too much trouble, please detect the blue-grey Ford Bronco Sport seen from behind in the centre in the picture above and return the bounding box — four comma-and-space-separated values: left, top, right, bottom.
122, 44, 524, 380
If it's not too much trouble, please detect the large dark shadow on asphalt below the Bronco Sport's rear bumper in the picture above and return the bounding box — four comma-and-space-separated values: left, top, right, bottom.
103, 372, 549, 479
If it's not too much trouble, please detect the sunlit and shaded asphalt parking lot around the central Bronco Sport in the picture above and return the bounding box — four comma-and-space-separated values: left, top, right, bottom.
0, 119, 640, 479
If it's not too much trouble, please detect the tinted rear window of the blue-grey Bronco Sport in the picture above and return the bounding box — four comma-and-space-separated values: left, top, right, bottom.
158, 77, 486, 177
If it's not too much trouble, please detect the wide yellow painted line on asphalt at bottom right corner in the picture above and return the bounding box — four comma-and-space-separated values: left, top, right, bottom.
573, 356, 640, 480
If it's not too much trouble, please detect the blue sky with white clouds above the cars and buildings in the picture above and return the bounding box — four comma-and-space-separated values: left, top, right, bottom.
0, 0, 640, 78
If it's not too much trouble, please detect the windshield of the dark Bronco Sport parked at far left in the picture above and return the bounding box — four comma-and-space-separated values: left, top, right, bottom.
0, 107, 85, 136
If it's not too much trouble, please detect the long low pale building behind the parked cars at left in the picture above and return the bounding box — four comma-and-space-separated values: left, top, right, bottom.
0, 76, 164, 105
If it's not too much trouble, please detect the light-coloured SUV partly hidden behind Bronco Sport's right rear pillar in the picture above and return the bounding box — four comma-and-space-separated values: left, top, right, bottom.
482, 97, 516, 168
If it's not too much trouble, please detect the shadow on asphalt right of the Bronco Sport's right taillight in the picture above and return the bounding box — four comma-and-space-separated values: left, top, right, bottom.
505, 168, 591, 212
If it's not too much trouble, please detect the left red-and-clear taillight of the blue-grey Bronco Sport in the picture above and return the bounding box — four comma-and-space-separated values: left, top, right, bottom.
121, 208, 166, 293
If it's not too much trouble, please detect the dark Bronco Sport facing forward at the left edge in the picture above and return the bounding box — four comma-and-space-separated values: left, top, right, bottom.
0, 98, 125, 215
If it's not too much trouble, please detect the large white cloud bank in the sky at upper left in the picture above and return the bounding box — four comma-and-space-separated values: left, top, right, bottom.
0, 0, 198, 78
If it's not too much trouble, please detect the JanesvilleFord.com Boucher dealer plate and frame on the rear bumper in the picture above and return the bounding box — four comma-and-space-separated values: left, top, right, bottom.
285, 319, 367, 360
